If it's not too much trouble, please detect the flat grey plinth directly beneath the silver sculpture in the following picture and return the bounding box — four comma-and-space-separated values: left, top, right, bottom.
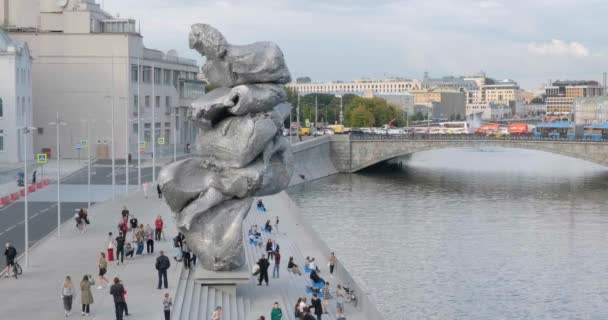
194, 263, 252, 294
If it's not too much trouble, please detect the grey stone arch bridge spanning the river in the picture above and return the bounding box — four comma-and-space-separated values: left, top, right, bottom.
329, 134, 608, 173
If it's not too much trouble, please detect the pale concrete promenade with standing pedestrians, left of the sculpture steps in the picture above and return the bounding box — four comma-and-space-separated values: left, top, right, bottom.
0, 193, 182, 320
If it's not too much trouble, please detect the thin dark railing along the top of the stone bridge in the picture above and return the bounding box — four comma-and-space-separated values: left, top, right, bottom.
349, 133, 608, 143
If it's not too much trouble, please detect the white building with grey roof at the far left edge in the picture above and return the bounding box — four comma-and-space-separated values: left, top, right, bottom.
0, 29, 35, 163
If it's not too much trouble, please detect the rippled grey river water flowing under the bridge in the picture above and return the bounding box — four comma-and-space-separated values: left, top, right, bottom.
289, 148, 608, 319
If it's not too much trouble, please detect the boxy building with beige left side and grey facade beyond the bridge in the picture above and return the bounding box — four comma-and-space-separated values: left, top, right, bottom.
412, 90, 465, 119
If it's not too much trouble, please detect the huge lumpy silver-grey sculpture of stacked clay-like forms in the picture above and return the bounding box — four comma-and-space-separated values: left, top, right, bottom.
159, 24, 293, 271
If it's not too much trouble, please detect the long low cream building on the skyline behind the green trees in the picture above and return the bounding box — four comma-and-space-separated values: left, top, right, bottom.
287, 78, 421, 95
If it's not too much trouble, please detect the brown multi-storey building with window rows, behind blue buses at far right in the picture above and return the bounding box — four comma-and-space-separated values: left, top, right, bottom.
545, 81, 604, 114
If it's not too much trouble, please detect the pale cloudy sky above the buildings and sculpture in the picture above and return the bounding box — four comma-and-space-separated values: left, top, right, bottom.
99, 0, 608, 89
